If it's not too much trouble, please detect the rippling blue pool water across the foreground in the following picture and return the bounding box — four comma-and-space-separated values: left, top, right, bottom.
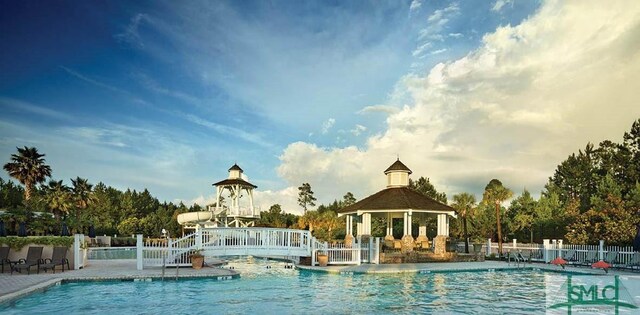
0, 258, 565, 314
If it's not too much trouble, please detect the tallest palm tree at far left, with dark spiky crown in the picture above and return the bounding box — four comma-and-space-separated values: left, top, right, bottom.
4, 146, 51, 201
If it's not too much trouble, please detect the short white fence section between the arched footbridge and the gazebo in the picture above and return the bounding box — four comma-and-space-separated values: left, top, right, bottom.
311, 237, 380, 266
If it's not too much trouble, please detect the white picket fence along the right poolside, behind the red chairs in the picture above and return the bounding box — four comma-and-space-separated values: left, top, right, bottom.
484, 240, 634, 265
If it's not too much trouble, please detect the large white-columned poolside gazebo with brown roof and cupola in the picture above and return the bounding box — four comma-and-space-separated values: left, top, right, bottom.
338, 159, 456, 253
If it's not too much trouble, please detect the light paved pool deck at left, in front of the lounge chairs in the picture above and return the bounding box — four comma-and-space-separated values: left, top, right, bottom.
0, 259, 239, 304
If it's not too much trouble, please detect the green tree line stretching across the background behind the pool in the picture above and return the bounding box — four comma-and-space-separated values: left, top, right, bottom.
0, 119, 640, 246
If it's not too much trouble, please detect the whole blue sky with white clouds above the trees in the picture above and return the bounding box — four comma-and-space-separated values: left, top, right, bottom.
0, 0, 638, 215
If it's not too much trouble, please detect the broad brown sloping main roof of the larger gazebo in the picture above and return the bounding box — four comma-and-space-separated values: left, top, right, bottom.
338, 188, 455, 213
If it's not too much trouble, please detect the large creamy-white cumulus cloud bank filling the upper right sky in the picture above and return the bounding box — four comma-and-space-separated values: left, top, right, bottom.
278, 1, 640, 201
